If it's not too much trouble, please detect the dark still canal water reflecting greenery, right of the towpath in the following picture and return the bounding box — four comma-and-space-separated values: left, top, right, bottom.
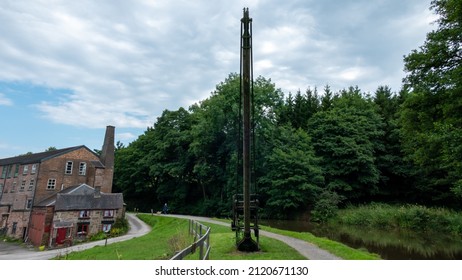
261, 220, 462, 260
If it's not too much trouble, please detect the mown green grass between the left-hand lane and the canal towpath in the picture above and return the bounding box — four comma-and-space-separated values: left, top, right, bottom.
59, 214, 305, 260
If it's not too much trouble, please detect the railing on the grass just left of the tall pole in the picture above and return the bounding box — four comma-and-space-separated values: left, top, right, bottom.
171, 220, 211, 260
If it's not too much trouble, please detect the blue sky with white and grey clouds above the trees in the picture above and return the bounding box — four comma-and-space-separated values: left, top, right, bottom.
0, 0, 436, 158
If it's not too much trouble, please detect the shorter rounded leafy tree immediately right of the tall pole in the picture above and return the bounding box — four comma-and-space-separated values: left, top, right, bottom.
259, 126, 324, 218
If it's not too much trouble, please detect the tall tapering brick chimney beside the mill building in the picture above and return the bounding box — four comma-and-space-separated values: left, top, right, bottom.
100, 125, 115, 193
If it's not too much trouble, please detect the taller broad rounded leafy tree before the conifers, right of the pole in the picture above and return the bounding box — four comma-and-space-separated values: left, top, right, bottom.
308, 88, 383, 201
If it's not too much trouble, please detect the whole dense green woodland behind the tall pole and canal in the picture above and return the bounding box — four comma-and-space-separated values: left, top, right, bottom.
114, 0, 462, 220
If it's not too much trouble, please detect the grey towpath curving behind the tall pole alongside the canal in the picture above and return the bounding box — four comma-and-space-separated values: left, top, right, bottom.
168, 214, 341, 260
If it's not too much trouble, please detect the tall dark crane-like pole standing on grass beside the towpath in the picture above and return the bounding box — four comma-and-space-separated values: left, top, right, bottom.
238, 8, 258, 252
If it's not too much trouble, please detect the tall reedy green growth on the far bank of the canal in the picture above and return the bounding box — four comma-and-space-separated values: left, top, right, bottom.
333, 203, 462, 236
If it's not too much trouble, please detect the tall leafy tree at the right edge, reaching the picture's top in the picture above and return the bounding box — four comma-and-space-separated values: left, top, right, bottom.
401, 0, 462, 204
